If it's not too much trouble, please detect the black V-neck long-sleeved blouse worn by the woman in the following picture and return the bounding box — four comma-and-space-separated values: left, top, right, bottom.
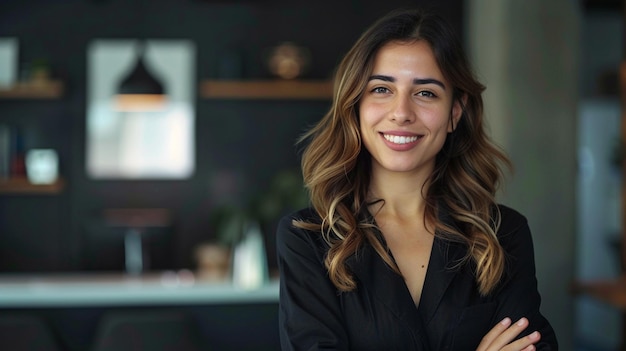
277, 206, 558, 351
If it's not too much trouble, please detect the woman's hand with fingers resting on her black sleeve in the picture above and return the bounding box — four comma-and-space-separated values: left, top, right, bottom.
476, 317, 541, 351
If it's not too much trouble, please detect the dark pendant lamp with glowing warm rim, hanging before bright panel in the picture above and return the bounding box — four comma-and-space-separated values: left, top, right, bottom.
115, 43, 166, 111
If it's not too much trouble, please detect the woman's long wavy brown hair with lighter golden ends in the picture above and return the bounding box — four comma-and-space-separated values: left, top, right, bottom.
294, 10, 511, 295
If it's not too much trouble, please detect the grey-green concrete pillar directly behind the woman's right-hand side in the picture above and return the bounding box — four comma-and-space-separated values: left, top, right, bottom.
466, 0, 581, 350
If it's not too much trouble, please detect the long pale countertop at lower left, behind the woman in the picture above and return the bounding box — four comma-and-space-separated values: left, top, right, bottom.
0, 271, 278, 308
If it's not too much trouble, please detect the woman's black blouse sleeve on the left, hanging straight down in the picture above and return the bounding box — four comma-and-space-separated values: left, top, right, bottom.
276, 212, 349, 351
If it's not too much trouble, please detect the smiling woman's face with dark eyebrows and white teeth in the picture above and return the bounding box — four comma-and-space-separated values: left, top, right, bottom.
359, 40, 462, 179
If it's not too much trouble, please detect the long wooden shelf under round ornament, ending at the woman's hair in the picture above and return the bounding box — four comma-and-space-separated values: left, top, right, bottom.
200, 80, 333, 100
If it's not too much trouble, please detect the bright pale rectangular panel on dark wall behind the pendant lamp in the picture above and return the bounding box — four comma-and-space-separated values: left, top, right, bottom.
86, 39, 195, 179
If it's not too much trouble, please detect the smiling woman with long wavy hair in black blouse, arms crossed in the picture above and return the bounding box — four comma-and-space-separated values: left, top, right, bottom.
277, 6, 558, 351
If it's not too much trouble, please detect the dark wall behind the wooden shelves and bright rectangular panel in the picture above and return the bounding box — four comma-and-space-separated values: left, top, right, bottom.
0, 0, 463, 272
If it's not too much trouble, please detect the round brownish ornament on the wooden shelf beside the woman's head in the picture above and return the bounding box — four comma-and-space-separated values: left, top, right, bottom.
267, 42, 311, 79
